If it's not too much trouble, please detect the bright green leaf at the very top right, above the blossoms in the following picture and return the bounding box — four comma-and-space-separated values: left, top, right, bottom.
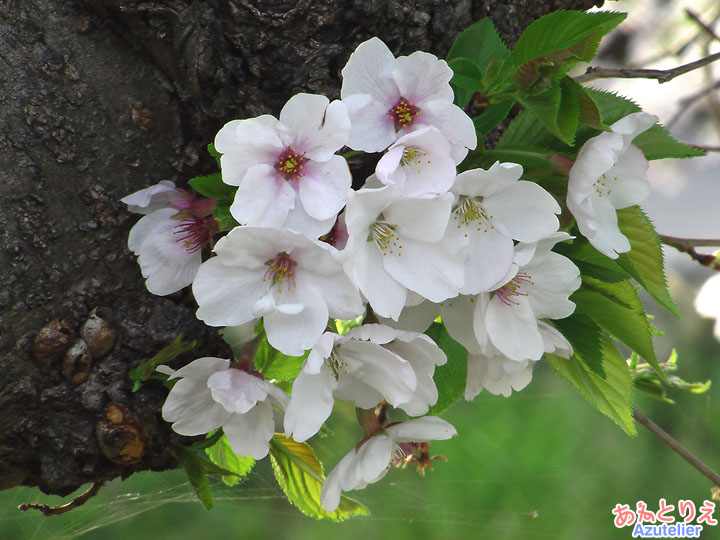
512, 11, 627, 67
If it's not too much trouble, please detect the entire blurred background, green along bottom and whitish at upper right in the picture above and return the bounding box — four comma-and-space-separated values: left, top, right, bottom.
0, 0, 720, 540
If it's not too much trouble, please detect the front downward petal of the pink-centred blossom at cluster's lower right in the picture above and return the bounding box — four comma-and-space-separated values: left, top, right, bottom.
485, 296, 545, 360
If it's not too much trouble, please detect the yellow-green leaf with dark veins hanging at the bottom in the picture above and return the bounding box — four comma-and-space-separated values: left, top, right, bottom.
270, 433, 370, 521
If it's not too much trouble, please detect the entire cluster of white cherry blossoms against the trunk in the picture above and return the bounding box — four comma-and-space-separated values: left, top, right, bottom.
123, 38, 655, 511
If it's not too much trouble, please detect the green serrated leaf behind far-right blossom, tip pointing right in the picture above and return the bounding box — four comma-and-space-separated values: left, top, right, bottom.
583, 88, 705, 160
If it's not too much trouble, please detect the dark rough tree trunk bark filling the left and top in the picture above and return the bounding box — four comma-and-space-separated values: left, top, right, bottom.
0, 0, 595, 495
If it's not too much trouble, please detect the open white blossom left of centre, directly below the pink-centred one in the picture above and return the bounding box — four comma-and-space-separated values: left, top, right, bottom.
193, 227, 364, 356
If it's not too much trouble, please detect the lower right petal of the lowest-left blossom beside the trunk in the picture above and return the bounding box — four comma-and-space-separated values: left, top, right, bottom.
222, 401, 275, 459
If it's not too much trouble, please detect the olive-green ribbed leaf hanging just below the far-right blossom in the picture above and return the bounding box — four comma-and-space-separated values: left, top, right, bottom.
617, 206, 680, 317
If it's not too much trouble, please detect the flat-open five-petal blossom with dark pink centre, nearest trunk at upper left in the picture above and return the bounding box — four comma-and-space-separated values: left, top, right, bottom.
215, 94, 352, 238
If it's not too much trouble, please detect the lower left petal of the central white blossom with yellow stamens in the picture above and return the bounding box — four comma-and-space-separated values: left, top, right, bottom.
345, 240, 407, 319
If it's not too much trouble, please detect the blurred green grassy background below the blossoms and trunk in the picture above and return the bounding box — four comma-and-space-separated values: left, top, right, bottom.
0, 278, 720, 540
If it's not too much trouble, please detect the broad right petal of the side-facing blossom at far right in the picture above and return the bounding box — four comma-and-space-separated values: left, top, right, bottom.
603, 145, 650, 209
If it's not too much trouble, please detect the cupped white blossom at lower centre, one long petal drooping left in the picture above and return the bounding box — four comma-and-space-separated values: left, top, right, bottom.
285, 324, 447, 441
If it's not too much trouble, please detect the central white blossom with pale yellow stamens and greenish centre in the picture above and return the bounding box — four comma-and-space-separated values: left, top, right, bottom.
342, 186, 464, 319
